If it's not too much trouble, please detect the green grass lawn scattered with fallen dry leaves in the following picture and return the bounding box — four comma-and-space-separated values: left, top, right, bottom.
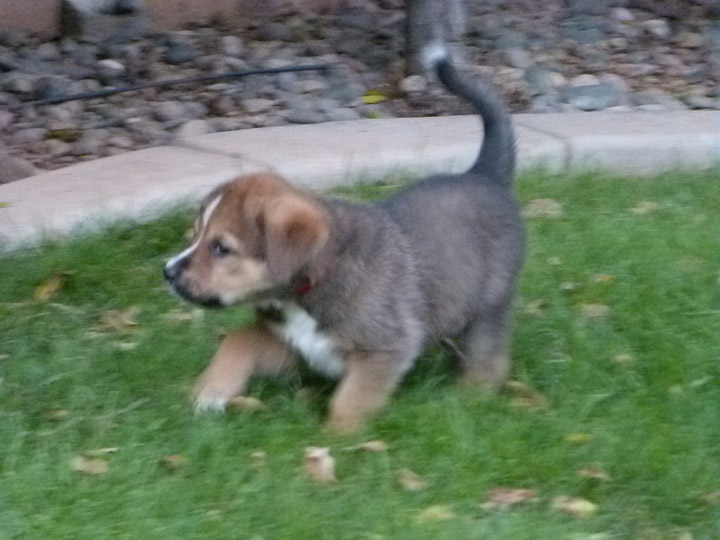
0, 170, 720, 540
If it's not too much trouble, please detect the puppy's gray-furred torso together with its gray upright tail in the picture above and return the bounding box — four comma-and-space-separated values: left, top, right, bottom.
292, 45, 525, 369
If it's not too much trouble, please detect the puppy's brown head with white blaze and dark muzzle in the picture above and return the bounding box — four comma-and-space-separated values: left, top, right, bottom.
163, 175, 329, 306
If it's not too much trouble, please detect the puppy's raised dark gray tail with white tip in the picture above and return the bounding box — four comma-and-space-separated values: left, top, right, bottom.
423, 43, 515, 185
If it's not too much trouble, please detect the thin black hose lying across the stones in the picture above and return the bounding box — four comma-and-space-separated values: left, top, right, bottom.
6, 64, 332, 110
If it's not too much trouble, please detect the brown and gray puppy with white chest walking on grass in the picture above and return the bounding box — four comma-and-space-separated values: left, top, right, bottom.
164, 46, 524, 432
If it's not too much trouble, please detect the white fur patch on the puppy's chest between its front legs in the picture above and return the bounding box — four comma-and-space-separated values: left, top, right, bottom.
273, 303, 345, 379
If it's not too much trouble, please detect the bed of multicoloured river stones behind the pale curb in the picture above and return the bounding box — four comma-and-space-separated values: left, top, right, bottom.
0, 0, 720, 183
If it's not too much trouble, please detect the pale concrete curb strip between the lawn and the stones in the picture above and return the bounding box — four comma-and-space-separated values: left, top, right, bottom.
0, 111, 720, 251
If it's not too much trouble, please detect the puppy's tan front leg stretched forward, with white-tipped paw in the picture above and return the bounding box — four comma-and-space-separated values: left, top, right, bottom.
193, 325, 295, 412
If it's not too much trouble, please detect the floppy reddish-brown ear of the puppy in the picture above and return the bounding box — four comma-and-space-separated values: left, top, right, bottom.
265, 197, 329, 283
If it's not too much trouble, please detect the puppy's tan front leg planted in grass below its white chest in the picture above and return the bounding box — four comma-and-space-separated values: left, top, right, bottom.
327, 354, 406, 434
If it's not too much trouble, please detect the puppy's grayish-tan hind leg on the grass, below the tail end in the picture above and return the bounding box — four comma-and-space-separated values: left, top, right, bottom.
459, 308, 510, 390
